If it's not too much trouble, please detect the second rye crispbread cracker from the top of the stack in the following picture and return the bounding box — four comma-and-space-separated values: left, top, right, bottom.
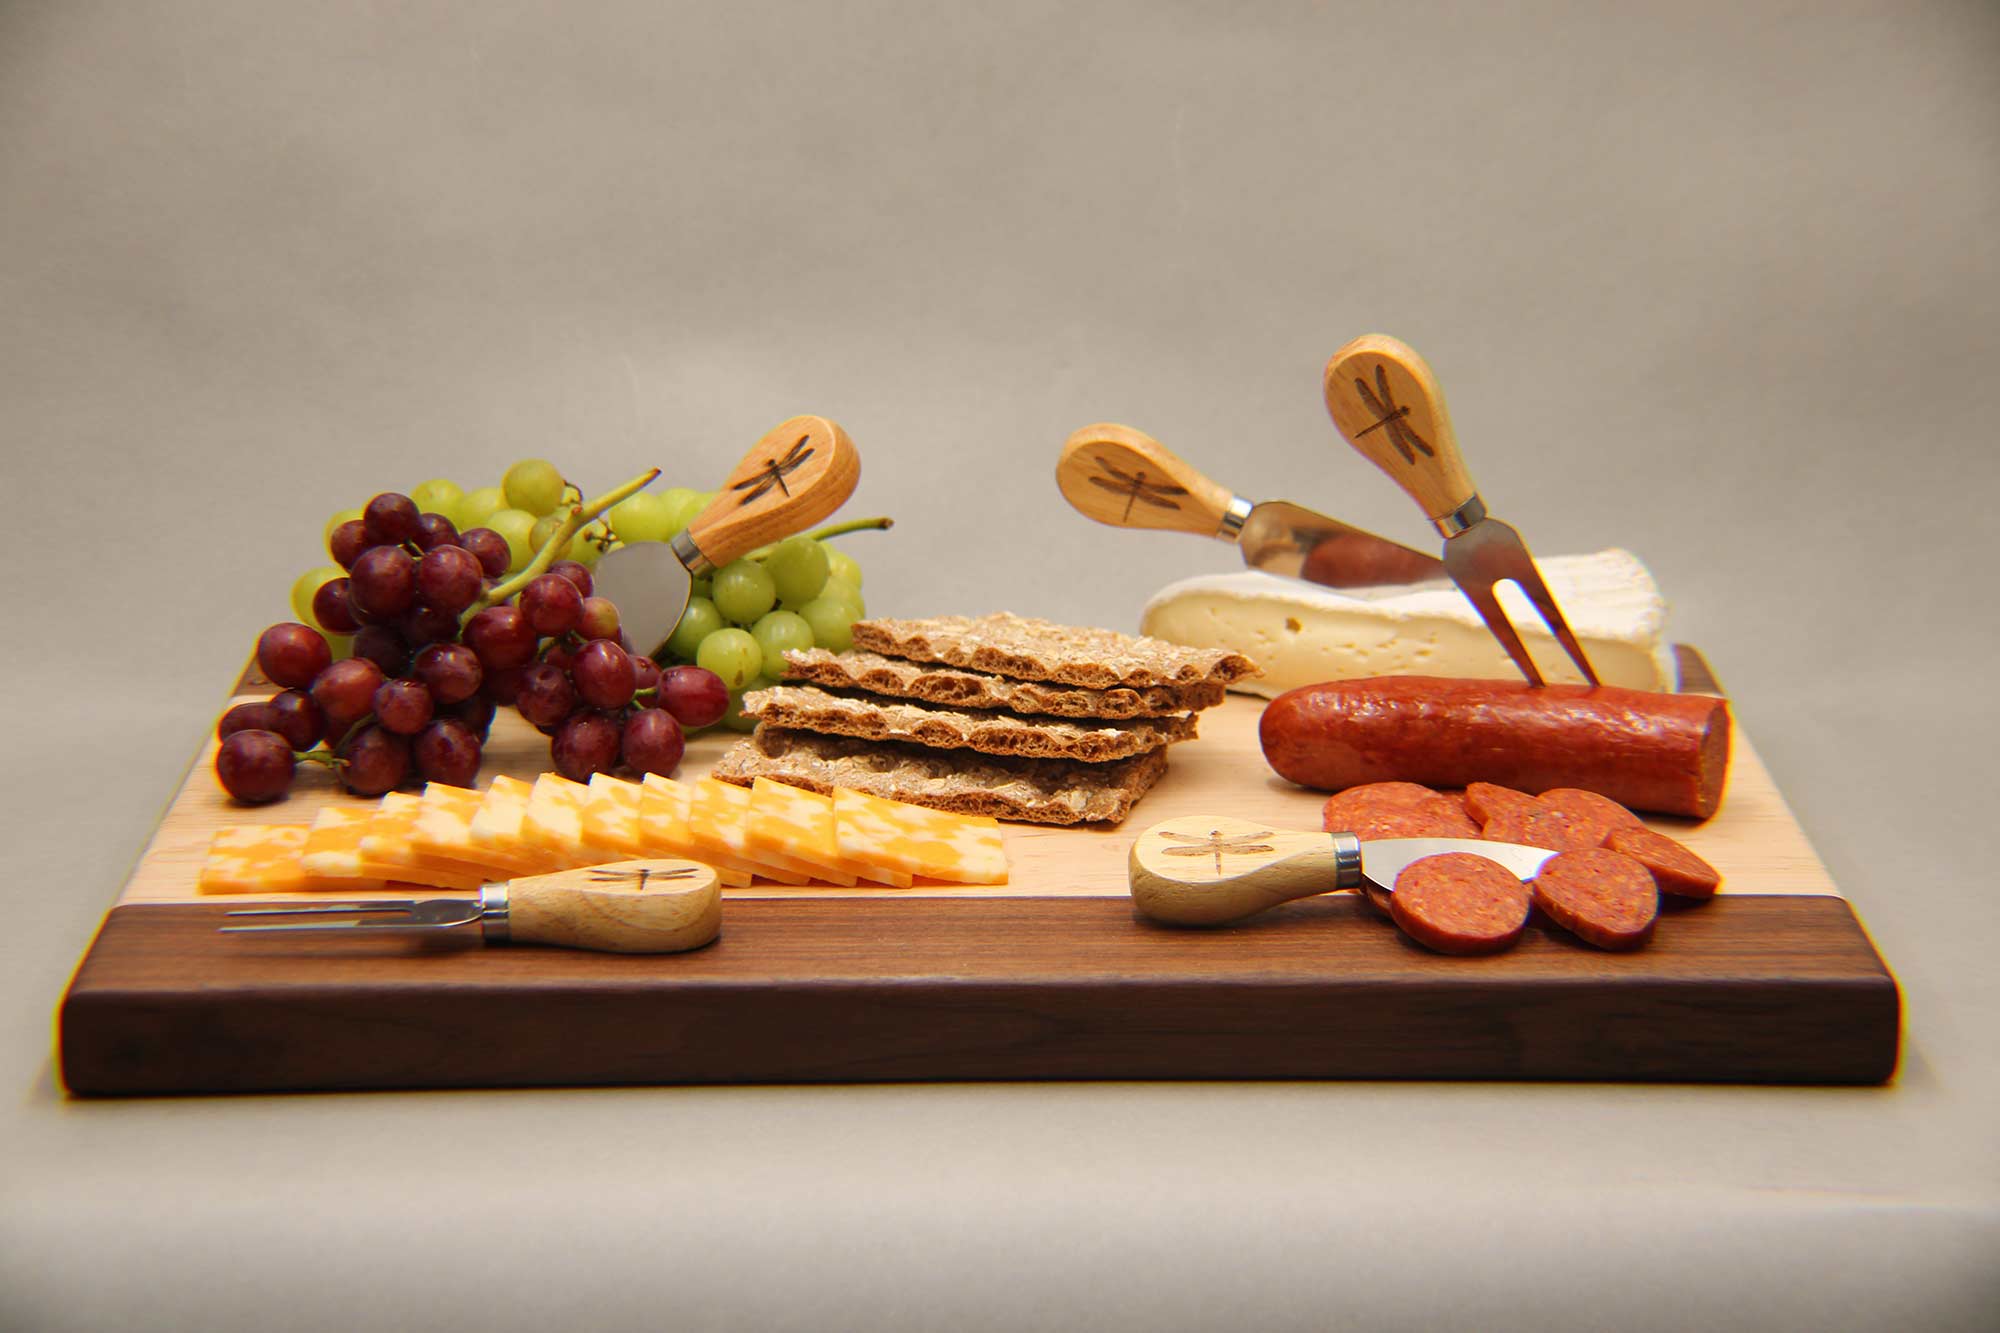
784, 648, 1226, 719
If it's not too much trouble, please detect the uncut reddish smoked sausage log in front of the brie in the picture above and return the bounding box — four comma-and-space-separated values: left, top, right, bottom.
1258, 677, 1730, 819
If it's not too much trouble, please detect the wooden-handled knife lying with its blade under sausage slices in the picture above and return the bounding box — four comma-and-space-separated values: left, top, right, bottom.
1126, 815, 1556, 925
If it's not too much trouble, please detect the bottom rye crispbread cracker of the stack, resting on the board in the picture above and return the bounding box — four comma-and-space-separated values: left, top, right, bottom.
714, 723, 1166, 825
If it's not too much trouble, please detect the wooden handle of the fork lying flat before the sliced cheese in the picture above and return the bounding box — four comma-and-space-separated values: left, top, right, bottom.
506, 859, 722, 953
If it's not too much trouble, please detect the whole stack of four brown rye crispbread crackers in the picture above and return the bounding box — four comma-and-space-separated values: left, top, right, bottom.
716, 612, 1258, 825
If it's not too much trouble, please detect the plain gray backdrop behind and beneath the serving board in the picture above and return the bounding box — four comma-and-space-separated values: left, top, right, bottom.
0, 0, 2000, 1329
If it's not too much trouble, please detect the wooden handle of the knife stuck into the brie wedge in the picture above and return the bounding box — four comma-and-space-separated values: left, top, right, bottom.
1056, 422, 1236, 536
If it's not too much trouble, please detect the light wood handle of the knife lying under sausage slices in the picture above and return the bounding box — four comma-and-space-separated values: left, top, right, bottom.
1126, 815, 1352, 925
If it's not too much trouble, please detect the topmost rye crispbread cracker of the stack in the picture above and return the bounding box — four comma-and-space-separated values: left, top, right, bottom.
854, 610, 1258, 691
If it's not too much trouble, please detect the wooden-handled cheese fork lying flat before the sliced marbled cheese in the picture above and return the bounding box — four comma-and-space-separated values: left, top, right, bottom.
222, 859, 722, 953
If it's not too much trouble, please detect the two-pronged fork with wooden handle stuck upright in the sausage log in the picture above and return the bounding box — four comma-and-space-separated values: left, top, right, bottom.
1324, 334, 1598, 685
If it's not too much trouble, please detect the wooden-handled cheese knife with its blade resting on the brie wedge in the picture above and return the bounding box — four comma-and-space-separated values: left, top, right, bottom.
1056, 422, 1446, 588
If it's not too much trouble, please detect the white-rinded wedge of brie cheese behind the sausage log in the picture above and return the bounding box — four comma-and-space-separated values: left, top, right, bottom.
1140, 550, 1674, 699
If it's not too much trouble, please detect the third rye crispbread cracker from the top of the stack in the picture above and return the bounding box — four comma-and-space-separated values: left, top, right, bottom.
742, 685, 1194, 765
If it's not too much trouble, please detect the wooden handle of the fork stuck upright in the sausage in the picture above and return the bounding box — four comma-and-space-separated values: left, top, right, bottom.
1326, 334, 1478, 520
